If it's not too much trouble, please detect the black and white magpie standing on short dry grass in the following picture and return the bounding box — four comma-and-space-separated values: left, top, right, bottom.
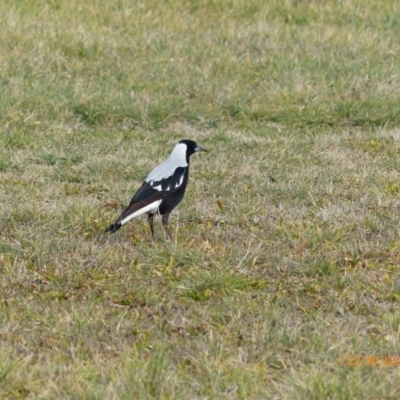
106, 140, 206, 238
